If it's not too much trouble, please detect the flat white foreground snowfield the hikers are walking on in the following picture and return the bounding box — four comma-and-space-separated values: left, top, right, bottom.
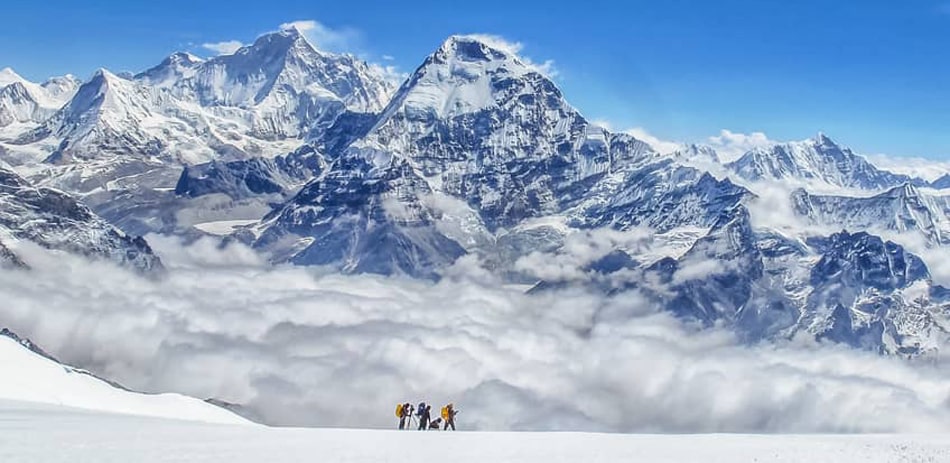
0, 401, 950, 463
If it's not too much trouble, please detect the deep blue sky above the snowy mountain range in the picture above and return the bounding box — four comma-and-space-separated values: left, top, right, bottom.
0, 0, 950, 159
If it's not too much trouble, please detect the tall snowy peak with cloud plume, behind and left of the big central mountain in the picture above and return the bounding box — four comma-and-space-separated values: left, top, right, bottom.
135, 28, 393, 117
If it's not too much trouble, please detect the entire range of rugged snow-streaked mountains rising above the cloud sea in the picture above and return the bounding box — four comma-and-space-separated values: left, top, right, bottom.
0, 29, 950, 355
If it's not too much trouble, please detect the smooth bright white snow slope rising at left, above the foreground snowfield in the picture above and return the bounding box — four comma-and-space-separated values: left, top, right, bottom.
0, 335, 250, 428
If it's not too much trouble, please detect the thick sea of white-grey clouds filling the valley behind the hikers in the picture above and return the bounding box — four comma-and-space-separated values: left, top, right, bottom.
0, 238, 950, 432
